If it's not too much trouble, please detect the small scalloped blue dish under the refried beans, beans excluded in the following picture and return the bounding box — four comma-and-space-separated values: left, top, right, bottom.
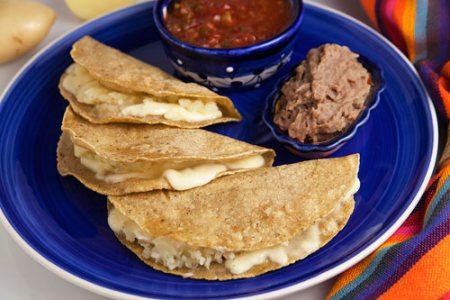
263, 55, 385, 159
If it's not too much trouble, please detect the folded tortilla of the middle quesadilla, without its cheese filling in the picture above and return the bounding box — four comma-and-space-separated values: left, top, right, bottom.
57, 108, 275, 195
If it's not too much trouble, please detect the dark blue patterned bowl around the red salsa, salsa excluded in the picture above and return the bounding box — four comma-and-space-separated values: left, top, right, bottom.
153, 0, 303, 91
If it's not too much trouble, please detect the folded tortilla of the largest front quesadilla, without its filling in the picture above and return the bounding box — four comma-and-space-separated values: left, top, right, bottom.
108, 155, 359, 280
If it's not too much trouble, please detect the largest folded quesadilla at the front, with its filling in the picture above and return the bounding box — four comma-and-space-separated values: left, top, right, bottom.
108, 154, 359, 280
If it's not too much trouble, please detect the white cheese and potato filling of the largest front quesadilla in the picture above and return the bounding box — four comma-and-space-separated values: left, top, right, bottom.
108, 181, 359, 276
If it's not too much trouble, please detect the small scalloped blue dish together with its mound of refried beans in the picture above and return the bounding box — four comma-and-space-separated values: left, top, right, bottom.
263, 44, 384, 158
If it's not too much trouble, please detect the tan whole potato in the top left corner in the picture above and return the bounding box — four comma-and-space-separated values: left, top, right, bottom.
0, 0, 56, 64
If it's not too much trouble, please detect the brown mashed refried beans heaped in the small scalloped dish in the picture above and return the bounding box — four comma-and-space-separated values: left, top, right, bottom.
274, 44, 371, 143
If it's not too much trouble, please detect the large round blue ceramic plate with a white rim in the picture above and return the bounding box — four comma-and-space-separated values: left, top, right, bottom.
0, 3, 437, 299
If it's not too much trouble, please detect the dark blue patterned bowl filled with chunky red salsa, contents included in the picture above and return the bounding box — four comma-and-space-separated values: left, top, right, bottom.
154, 0, 303, 91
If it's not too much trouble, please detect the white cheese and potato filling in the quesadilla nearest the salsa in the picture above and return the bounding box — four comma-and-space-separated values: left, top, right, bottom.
62, 64, 222, 122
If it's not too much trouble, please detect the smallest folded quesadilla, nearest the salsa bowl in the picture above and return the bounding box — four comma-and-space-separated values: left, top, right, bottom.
59, 36, 241, 128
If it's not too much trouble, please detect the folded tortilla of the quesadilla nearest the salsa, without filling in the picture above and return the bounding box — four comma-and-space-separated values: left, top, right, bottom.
59, 36, 241, 128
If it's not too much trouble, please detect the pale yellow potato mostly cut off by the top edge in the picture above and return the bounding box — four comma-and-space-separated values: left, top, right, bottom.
66, 0, 135, 20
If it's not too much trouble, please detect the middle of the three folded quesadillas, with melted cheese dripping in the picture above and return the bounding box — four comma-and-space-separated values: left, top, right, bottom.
57, 108, 275, 195
